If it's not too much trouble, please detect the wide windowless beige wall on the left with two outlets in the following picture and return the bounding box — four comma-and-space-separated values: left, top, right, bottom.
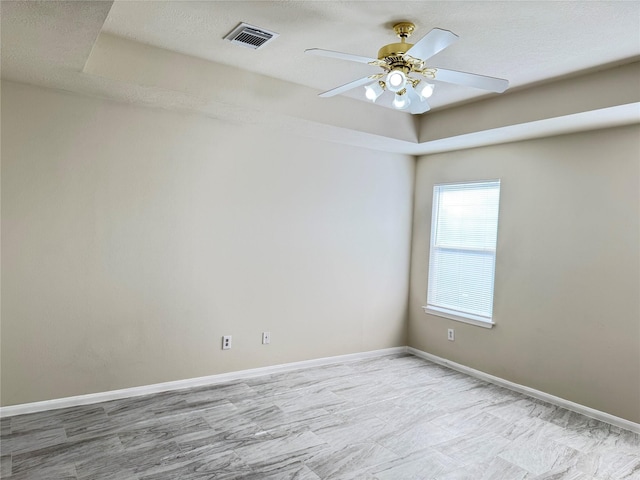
1, 82, 415, 405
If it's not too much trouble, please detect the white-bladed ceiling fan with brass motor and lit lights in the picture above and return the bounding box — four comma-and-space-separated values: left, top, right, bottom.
305, 22, 509, 114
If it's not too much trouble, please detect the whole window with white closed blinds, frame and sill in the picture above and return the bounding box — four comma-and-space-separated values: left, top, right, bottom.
424, 180, 500, 328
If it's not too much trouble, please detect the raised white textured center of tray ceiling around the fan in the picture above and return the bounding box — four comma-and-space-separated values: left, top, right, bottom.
104, 1, 640, 107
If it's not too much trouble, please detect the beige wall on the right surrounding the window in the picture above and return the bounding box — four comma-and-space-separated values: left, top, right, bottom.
409, 125, 640, 422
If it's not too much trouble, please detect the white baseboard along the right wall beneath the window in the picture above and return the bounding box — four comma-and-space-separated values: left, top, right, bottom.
407, 347, 640, 433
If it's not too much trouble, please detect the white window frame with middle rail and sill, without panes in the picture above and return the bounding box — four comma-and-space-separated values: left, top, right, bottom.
422, 179, 501, 328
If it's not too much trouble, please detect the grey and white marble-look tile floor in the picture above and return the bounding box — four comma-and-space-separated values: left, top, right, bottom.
0, 355, 640, 480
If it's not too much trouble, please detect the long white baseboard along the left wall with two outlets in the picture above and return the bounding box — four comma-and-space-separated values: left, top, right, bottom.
0, 347, 407, 418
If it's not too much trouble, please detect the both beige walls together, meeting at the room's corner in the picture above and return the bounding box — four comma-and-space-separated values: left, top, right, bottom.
1, 78, 640, 422
